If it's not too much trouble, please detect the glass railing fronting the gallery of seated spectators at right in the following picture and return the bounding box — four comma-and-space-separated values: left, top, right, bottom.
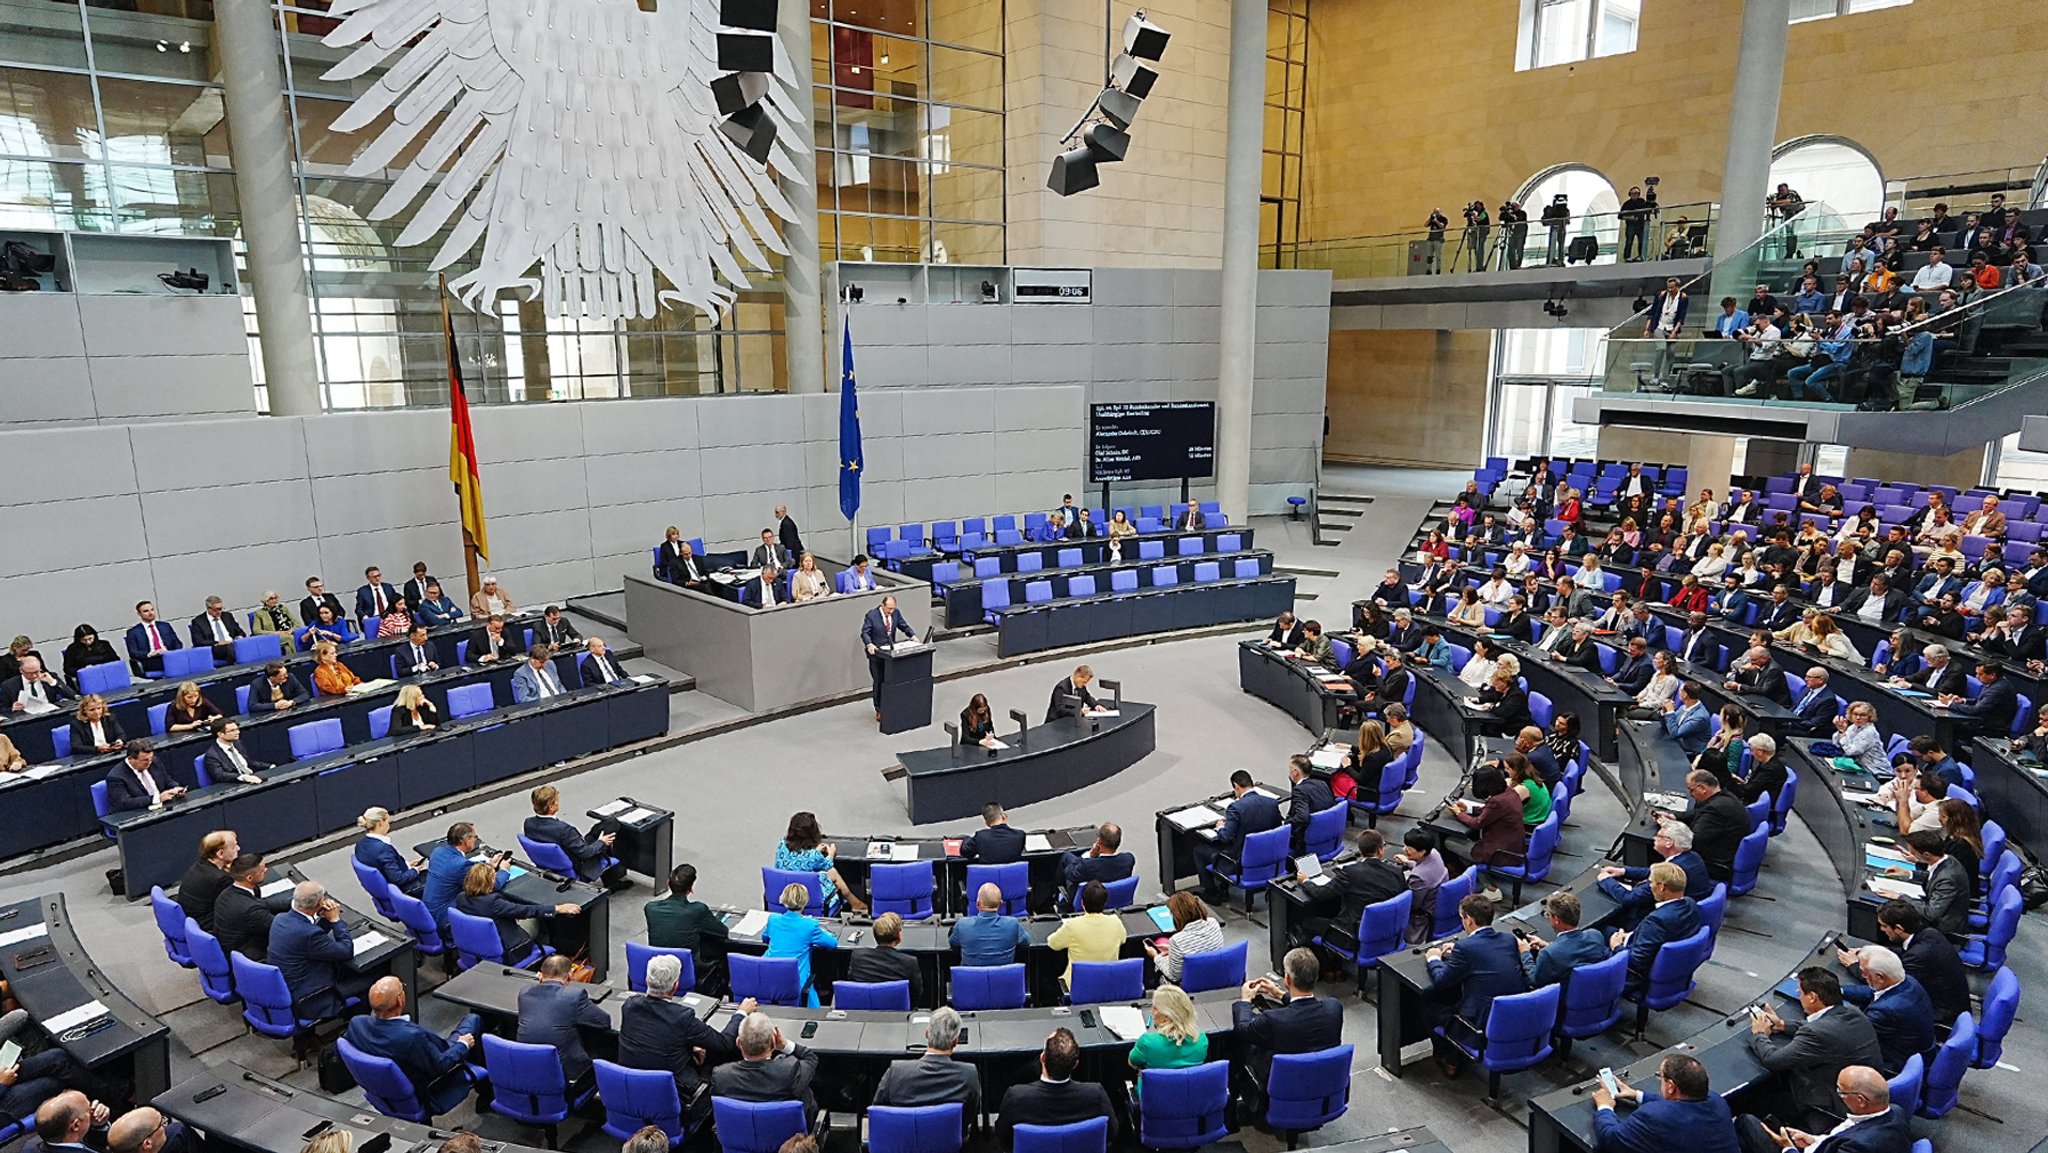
1602, 205, 2048, 412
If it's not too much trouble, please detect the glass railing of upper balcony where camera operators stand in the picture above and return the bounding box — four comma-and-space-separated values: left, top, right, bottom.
1262, 203, 1720, 281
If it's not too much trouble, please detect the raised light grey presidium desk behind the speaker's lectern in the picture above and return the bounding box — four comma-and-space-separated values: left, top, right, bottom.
625, 553, 932, 713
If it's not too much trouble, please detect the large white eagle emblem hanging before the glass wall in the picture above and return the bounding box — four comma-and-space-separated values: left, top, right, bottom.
324, 0, 811, 319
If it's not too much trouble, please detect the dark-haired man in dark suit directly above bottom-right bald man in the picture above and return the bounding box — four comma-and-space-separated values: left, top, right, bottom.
1749, 965, 1884, 1133
